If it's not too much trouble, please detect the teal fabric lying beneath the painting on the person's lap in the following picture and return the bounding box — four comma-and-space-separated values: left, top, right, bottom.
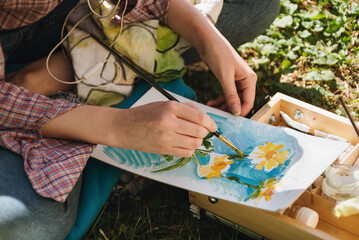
66, 79, 196, 240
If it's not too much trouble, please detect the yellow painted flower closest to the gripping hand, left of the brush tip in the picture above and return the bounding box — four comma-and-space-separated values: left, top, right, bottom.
197, 155, 234, 179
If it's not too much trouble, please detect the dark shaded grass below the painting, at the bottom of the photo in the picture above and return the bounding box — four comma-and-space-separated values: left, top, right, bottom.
85, 180, 253, 239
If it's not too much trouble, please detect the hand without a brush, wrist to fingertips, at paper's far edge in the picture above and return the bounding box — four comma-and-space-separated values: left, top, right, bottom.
201, 34, 257, 116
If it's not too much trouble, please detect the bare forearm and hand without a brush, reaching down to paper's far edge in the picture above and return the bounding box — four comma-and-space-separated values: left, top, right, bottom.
168, 0, 257, 116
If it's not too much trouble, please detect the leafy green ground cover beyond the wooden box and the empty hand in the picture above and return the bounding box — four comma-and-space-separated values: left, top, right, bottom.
187, 0, 359, 121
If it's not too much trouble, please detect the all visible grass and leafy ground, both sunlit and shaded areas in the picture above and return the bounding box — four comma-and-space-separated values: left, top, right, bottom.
85, 0, 359, 239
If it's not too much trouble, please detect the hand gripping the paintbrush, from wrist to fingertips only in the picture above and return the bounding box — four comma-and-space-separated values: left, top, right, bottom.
110, 101, 217, 157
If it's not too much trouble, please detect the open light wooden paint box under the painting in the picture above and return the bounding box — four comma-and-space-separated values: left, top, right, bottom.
189, 93, 359, 240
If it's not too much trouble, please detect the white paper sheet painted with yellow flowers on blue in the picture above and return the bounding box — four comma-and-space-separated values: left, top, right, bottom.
93, 88, 347, 212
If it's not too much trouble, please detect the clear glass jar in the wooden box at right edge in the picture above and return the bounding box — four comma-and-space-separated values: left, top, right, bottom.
322, 164, 359, 201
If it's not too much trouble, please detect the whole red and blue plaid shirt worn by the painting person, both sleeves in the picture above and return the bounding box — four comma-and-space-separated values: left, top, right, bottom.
0, 0, 169, 202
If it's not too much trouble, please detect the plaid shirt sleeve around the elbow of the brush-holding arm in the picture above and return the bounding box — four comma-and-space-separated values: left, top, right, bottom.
0, 81, 94, 202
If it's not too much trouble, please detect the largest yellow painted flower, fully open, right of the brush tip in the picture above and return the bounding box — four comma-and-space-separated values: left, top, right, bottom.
248, 142, 289, 171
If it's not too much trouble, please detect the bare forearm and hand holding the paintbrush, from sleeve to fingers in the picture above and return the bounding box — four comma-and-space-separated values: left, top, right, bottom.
41, 101, 217, 157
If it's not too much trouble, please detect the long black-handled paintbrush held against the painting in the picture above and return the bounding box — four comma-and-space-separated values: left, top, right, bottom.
91, 35, 244, 157
